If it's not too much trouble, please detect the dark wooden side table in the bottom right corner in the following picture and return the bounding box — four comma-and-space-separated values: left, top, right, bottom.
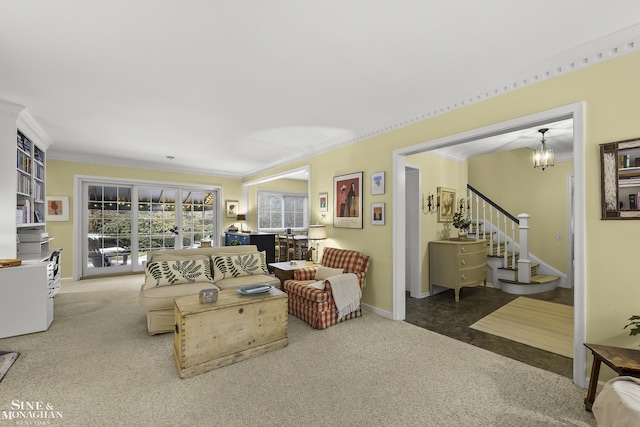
584, 344, 640, 412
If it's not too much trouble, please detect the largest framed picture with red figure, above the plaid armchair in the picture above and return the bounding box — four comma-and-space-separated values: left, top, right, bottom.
333, 172, 363, 228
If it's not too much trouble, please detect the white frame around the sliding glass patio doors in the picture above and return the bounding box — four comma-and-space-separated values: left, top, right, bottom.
72, 175, 223, 281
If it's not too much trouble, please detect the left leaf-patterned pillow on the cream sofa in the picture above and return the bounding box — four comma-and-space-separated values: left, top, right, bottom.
144, 259, 213, 289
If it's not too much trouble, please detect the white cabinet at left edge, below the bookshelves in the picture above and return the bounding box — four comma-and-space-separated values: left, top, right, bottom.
0, 250, 60, 338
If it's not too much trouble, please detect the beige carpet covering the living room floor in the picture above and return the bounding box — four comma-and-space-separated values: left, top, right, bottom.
0, 277, 595, 427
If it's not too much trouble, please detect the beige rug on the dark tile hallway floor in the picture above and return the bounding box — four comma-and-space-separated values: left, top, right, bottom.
470, 297, 573, 358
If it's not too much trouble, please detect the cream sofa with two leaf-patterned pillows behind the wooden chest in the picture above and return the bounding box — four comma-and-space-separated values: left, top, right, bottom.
139, 245, 280, 335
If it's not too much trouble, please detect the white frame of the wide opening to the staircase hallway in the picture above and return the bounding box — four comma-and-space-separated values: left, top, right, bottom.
392, 102, 587, 388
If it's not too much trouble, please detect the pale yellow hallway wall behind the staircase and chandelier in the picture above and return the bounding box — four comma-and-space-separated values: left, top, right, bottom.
469, 147, 573, 274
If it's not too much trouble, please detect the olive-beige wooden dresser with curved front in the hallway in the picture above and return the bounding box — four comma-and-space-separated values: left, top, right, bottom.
429, 240, 487, 301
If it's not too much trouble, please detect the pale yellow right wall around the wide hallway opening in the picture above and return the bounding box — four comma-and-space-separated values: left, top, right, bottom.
250, 53, 640, 356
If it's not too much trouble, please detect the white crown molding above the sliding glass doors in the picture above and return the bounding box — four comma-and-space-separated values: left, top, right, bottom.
47, 150, 242, 179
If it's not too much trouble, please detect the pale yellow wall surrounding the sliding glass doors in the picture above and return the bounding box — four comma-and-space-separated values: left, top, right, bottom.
46, 160, 242, 277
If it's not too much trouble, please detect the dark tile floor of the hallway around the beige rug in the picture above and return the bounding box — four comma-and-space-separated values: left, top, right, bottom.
405, 286, 573, 378
